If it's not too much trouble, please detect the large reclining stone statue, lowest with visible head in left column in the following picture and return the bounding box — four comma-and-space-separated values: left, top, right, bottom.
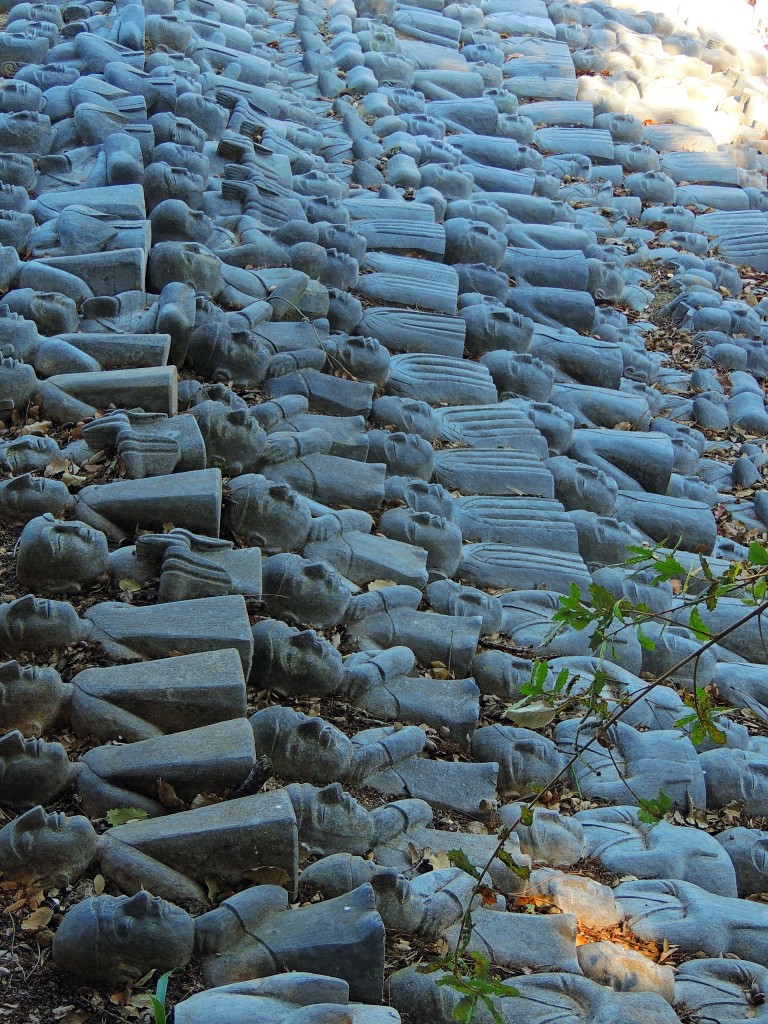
53, 885, 384, 1002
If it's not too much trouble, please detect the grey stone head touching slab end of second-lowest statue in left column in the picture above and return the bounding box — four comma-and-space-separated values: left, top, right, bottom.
286, 782, 375, 854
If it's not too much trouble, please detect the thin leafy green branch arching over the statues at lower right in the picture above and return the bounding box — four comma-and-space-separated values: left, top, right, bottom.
419, 542, 768, 1024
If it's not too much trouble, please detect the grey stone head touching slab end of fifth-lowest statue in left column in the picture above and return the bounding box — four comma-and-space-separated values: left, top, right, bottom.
253, 618, 342, 693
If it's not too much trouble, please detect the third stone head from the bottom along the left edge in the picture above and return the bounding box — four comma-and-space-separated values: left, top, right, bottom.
0, 729, 76, 807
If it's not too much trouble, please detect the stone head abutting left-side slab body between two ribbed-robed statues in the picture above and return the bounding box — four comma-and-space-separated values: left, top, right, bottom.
226, 473, 312, 555
